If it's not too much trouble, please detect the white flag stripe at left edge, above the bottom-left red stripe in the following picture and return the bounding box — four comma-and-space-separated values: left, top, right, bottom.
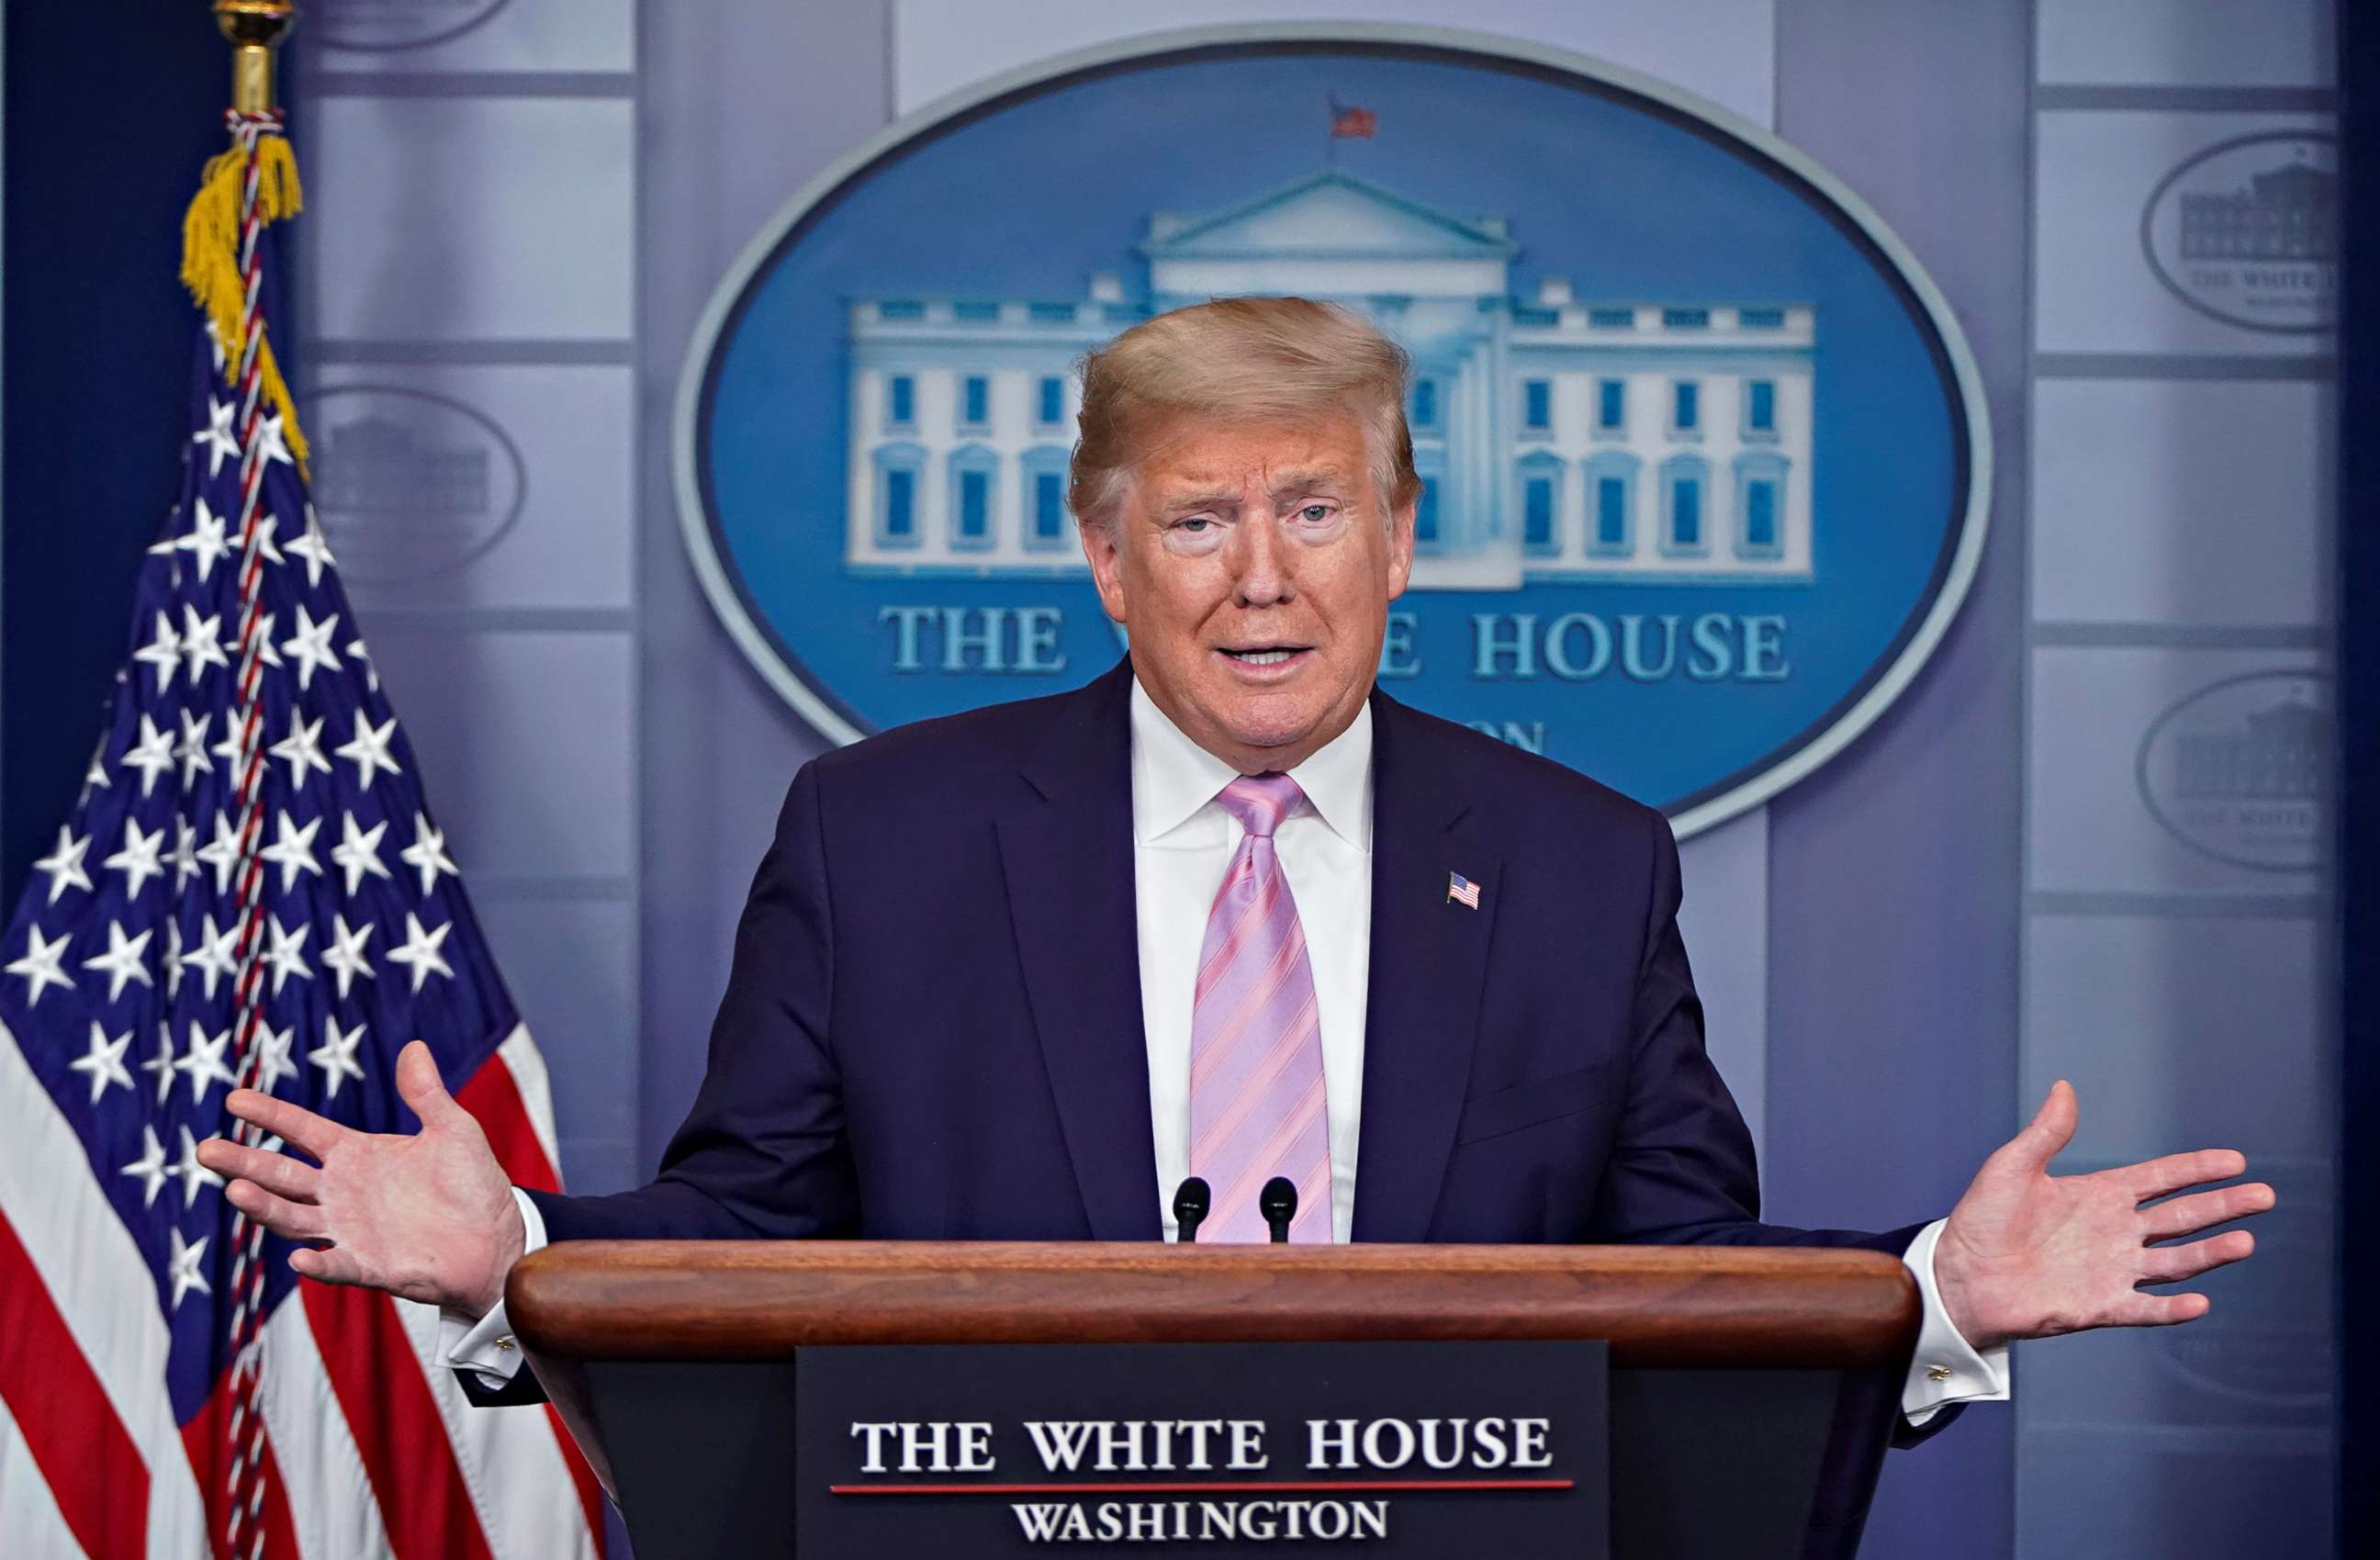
0, 1024, 208, 1560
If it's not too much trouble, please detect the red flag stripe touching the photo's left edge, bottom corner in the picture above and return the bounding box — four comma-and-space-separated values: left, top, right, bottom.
0, 1209, 148, 1560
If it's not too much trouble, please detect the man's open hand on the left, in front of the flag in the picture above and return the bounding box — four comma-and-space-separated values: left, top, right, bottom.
197, 1041, 526, 1317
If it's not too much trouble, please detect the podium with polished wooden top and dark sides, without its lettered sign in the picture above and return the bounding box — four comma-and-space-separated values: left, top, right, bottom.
507, 1240, 1918, 1560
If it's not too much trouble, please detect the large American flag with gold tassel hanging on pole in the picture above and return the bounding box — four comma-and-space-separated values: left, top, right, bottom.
0, 117, 602, 1560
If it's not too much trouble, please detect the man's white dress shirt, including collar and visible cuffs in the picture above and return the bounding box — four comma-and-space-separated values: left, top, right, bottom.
443, 679, 2009, 1424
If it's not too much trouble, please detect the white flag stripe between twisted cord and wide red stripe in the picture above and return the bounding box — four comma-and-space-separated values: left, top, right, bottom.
264, 1305, 393, 1560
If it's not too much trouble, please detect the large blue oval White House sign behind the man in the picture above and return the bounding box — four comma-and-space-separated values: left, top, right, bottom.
676, 24, 1990, 836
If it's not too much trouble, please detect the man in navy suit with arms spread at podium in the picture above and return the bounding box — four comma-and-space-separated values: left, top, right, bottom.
200, 297, 2273, 1539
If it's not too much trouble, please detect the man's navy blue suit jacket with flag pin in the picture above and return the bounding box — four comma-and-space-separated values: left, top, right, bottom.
501, 665, 1947, 1533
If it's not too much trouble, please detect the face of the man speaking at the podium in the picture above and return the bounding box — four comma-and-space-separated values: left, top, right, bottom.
1083, 417, 1414, 774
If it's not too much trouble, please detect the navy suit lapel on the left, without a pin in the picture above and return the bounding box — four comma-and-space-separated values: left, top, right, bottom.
1000, 665, 1162, 1240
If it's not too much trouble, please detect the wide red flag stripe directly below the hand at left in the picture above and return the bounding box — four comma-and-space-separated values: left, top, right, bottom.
298, 1279, 493, 1560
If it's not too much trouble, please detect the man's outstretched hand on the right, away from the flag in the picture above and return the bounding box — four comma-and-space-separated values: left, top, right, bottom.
1935, 1079, 2273, 1348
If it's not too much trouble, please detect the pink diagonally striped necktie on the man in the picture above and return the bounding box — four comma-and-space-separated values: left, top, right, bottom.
1190, 774, 1330, 1240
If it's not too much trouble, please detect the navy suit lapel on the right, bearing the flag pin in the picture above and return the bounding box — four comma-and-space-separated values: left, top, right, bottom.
1354, 693, 1502, 1240
